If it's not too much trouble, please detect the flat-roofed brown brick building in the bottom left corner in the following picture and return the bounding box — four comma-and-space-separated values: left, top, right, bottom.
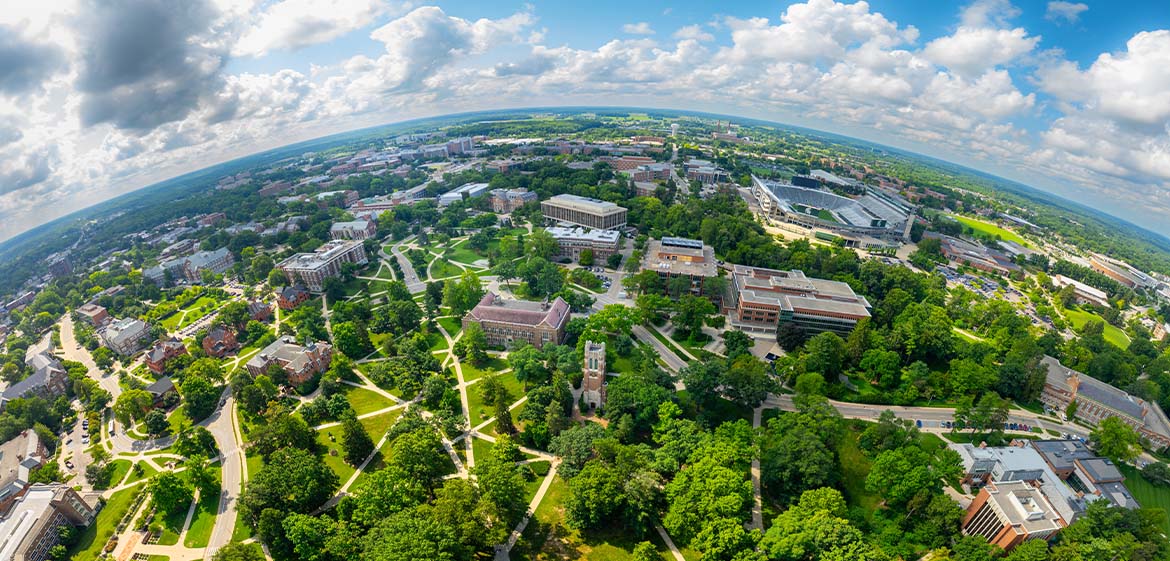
0, 484, 97, 561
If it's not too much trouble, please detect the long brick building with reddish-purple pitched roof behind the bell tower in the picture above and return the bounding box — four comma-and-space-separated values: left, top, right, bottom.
463, 292, 569, 349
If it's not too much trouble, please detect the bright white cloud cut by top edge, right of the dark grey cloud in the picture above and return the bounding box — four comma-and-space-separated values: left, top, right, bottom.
233, 0, 391, 56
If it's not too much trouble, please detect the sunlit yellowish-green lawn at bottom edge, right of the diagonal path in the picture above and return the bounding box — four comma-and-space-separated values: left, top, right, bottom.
510, 477, 678, 561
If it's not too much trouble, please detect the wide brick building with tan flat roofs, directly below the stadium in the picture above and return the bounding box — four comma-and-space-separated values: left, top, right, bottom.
723, 265, 872, 334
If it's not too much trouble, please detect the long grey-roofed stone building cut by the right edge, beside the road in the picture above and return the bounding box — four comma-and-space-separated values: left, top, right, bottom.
1040, 356, 1170, 447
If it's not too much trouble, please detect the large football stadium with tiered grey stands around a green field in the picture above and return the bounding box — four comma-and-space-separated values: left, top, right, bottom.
751, 176, 914, 248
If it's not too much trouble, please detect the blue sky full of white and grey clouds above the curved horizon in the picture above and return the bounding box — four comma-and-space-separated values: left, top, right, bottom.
0, 0, 1170, 240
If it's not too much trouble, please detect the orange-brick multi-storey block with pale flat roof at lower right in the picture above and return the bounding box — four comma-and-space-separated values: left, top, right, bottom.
961, 481, 1066, 550
